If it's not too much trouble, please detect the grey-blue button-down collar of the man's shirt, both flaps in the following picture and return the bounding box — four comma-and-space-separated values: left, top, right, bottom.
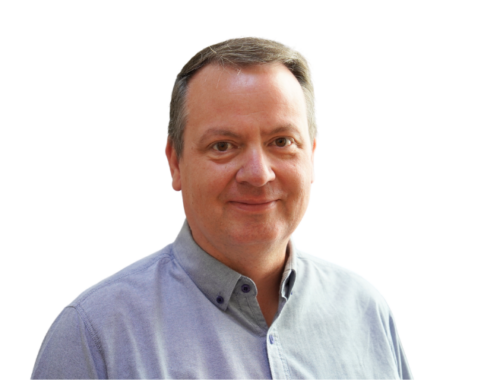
174, 220, 296, 310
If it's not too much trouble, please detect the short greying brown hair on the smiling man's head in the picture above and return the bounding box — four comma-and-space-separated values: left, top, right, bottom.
168, 37, 316, 158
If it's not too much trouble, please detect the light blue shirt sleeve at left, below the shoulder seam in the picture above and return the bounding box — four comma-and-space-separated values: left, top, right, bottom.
31, 306, 107, 379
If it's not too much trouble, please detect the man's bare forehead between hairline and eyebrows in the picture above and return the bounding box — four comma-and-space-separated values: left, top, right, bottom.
186, 63, 306, 130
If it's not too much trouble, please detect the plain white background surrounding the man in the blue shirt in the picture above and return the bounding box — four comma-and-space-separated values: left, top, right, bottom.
0, 0, 500, 379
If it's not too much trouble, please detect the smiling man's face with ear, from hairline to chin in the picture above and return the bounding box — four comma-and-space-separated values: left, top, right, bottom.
167, 64, 315, 251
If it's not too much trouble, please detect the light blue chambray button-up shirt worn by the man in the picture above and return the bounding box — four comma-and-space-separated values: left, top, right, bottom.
32, 222, 411, 379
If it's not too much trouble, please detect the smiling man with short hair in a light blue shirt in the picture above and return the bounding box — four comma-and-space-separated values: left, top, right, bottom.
33, 38, 411, 379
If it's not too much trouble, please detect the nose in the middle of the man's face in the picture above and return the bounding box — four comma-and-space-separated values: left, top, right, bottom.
236, 149, 276, 187
